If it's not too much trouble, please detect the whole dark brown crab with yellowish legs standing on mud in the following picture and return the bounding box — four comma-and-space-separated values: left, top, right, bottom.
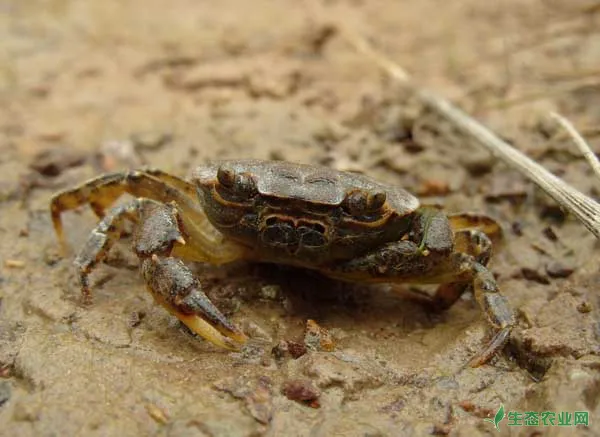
50, 160, 515, 367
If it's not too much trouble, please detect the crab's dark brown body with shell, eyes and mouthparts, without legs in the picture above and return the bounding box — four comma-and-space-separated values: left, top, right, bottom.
194, 160, 419, 268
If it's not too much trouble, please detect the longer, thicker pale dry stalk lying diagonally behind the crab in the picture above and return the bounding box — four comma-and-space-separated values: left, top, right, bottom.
337, 24, 600, 239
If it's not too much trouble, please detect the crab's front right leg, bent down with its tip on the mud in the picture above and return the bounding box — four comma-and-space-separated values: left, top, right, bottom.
324, 241, 515, 367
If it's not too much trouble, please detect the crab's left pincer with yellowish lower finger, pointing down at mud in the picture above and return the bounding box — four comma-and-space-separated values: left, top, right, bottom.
141, 255, 248, 350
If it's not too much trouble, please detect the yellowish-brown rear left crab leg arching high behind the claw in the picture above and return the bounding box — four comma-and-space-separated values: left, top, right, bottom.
50, 170, 243, 264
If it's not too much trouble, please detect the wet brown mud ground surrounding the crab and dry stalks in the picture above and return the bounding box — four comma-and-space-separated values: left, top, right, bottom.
0, 0, 600, 436
